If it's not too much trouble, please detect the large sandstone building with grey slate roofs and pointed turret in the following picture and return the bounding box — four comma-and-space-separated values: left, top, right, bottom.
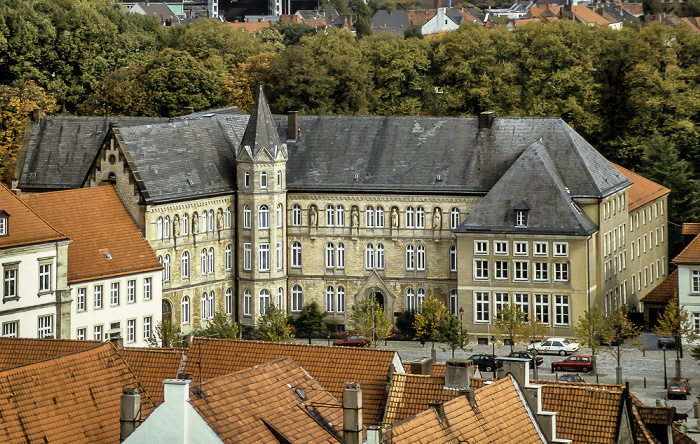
15, 90, 666, 338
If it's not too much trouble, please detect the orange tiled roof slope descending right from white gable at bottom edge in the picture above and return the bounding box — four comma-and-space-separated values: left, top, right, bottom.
190, 357, 343, 444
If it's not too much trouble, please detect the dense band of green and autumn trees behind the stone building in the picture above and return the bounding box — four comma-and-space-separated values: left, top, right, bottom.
0, 0, 700, 250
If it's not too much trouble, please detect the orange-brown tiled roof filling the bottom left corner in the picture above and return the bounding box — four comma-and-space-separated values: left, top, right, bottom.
0, 342, 155, 444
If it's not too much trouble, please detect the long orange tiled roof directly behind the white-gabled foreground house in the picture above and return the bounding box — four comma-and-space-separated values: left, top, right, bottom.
185, 338, 397, 424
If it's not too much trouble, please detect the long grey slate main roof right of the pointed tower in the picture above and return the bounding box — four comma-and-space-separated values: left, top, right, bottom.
278, 116, 630, 197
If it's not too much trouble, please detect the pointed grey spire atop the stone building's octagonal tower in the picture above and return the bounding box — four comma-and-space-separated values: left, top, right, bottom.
241, 85, 282, 159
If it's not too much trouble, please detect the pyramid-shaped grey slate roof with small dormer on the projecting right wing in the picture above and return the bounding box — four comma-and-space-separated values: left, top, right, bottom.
455, 142, 597, 236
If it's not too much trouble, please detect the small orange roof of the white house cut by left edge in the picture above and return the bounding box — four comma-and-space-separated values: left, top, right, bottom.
0, 185, 68, 248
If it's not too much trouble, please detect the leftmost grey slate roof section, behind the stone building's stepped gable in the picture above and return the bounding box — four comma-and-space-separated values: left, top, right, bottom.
17, 116, 169, 190
